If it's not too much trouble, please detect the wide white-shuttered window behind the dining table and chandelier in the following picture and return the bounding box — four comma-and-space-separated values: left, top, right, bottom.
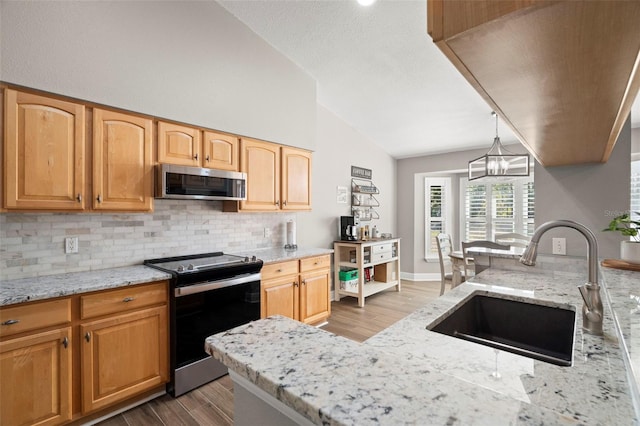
460, 177, 535, 241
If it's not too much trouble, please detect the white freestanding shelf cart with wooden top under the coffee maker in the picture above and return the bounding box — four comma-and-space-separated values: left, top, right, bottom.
333, 238, 400, 308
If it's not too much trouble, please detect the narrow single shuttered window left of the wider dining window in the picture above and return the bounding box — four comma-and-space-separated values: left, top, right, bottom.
424, 177, 453, 259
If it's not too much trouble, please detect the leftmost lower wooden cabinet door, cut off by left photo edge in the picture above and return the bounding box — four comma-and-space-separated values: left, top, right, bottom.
0, 327, 71, 425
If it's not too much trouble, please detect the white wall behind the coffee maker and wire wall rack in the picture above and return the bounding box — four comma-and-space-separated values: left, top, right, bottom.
297, 105, 398, 250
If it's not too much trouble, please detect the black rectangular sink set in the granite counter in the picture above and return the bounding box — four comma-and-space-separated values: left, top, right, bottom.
427, 293, 576, 367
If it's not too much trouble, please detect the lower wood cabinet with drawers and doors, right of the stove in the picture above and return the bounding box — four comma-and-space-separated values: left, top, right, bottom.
261, 255, 331, 324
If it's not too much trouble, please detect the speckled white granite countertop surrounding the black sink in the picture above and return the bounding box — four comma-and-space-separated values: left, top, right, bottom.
205, 264, 640, 425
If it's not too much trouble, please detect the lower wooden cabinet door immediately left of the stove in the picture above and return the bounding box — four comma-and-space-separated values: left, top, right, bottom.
80, 306, 169, 413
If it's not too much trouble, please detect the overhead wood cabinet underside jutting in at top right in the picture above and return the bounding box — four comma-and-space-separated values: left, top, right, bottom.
427, 0, 640, 166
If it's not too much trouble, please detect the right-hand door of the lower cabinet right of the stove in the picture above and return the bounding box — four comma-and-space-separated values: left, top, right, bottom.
300, 270, 331, 324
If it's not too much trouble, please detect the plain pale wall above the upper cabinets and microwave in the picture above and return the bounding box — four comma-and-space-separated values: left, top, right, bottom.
0, 1, 316, 149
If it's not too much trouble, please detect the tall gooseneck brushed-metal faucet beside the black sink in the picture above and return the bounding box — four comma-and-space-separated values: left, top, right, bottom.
520, 220, 603, 336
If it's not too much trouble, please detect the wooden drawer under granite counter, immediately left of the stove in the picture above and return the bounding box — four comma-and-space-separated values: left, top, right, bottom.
80, 281, 167, 319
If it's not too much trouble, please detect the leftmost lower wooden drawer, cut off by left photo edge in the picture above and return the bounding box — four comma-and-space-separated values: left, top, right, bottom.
0, 298, 71, 336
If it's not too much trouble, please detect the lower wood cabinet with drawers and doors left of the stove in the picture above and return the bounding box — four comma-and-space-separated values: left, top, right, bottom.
0, 281, 169, 426
